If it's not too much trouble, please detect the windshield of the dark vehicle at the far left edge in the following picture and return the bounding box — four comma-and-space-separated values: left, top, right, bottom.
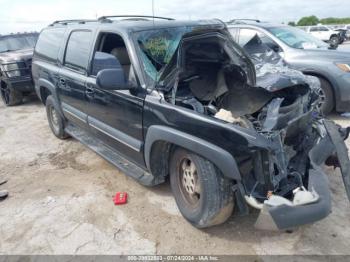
0, 35, 37, 53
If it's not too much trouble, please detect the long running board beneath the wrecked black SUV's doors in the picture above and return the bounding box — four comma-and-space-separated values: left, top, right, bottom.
65, 123, 161, 186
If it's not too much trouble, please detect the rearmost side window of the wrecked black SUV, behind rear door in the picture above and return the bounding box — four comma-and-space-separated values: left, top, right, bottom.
35, 28, 65, 61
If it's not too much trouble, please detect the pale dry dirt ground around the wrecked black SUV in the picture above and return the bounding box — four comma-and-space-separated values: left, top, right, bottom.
0, 95, 350, 255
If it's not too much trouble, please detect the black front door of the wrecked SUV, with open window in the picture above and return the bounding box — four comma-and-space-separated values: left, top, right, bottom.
86, 33, 145, 166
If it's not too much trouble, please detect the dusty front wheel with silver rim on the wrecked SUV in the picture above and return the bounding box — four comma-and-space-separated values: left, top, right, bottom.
170, 148, 234, 228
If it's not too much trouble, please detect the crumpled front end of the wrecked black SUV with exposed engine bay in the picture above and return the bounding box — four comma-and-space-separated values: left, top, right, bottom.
150, 27, 349, 229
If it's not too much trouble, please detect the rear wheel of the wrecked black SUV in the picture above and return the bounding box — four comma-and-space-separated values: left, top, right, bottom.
46, 95, 69, 139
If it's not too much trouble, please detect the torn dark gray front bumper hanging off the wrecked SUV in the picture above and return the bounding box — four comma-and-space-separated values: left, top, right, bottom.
255, 121, 350, 230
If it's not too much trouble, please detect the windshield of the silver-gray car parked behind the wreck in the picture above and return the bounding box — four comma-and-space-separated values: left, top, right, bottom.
267, 26, 328, 49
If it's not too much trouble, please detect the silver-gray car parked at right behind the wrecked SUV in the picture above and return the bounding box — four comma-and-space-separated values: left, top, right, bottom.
228, 19, 350, 114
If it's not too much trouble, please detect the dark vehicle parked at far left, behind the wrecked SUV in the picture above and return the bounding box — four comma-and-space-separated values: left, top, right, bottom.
0, 33, 38, 106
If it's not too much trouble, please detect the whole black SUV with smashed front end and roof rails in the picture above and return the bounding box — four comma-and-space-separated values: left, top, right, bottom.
32, 16, 349, 229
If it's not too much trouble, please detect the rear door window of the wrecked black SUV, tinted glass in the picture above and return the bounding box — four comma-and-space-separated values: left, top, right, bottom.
64, 31, 92, 71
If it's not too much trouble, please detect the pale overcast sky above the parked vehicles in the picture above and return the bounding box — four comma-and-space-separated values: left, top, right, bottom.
0, 0, 350, 34
